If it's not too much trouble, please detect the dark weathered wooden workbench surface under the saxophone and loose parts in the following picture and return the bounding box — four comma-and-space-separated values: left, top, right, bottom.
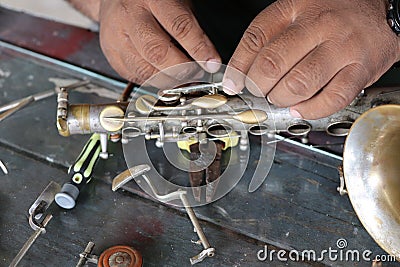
0, 9, 398, 266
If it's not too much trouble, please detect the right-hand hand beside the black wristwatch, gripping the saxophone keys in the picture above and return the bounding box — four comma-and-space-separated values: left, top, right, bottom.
224, 0, 400, 119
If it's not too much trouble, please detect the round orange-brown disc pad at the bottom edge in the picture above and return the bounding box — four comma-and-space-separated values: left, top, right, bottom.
98, 246, 142, 267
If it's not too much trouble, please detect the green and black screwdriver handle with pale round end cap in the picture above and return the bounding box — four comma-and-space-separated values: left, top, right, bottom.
55, 133, 101, 209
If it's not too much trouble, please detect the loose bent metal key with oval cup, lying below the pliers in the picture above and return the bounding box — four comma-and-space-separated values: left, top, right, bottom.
112, 164, 215, 264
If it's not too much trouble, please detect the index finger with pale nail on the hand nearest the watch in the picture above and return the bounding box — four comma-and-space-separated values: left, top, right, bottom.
224, 1, 300, 94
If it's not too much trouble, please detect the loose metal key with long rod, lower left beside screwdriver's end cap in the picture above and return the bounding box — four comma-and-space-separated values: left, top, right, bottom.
9, 181, 60, 267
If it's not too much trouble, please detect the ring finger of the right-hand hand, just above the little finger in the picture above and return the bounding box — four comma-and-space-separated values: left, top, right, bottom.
268, 41, 349, 107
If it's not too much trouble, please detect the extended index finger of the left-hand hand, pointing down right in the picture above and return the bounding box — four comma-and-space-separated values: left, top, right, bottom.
149, 0, 221, 73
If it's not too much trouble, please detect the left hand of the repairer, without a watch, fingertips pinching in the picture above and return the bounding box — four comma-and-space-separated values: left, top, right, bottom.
100, 0, 221, 84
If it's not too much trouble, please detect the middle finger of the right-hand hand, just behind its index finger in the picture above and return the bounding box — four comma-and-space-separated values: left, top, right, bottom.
248, 20, 320, 97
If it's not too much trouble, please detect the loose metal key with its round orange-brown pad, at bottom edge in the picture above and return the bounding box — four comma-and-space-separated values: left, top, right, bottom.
76, 241, 143, 267
